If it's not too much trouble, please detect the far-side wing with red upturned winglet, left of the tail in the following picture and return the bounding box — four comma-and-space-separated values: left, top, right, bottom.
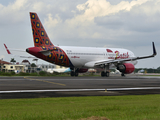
4, 44, 37, 59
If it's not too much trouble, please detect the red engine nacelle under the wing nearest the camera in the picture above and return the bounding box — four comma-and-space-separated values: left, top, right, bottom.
117, 63, 135, 74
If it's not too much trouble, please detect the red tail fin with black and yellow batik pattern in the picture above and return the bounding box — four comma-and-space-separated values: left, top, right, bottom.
30, 12, 53, 47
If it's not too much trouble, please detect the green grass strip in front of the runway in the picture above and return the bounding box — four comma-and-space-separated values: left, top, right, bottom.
0, 95, 160, 120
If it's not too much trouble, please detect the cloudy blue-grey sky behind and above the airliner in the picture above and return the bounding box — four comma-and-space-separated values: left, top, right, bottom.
0, 0, 160, 68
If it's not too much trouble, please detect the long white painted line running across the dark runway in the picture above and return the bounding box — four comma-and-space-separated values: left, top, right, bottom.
0, 87, 160, 93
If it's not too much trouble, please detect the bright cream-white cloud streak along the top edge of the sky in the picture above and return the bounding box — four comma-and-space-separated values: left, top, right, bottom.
77, 0, 148, 21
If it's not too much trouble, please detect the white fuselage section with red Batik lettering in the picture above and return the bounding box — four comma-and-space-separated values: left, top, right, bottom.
59, 46, 137, 68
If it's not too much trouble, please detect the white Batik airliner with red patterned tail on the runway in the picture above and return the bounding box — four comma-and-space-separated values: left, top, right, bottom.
7, 12, 157, 77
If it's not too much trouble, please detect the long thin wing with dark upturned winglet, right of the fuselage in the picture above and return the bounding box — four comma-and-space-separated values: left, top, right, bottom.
94, 42, 157, 66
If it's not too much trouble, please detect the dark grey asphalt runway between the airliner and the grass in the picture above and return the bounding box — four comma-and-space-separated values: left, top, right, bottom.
0, 76, 160, 99
